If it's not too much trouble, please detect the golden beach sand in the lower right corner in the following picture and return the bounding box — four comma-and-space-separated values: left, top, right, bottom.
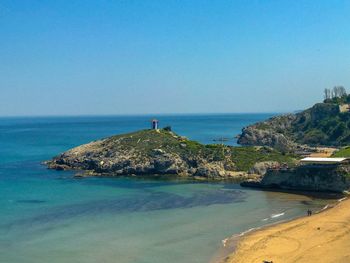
225, 199, 350, 263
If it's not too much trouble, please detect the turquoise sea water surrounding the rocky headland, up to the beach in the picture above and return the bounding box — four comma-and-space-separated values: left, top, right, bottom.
0, 114, 325, 263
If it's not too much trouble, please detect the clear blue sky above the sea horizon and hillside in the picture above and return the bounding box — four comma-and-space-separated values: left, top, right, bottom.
0, 0, 350, 116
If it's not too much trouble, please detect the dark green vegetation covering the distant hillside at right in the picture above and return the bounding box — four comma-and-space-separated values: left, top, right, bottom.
249, 99, 350, 146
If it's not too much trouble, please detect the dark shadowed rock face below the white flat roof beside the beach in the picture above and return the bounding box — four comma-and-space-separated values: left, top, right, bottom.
243, 165, 350, 192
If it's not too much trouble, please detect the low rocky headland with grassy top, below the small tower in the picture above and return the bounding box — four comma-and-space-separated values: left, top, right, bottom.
46, 129, 295, 180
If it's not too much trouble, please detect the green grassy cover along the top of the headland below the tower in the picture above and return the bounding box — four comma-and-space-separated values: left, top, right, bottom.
105, 129, 295, 171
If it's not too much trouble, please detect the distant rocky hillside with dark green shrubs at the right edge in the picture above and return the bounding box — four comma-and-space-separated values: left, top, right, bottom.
238, 95, 350, 151
